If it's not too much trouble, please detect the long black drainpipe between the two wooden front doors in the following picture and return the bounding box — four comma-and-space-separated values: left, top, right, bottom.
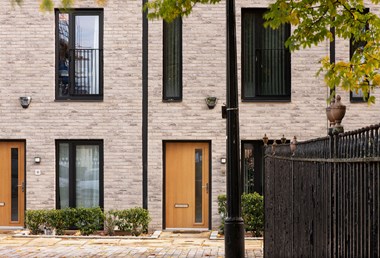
142, 0, 148, 209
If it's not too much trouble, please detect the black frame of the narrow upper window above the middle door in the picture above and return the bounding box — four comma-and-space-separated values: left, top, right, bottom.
162, 17, 183, 102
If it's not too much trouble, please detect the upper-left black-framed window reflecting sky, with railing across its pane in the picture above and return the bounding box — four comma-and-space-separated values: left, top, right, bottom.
55, 9, 103, 100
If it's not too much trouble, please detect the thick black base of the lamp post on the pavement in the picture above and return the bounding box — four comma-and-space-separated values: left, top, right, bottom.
224, 217, 245, 258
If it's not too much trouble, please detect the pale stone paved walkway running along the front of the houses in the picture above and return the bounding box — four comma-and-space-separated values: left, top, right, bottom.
0, 232, 263, 258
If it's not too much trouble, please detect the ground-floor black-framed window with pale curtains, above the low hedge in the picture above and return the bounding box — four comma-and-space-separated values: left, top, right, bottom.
56, 140, 103, 209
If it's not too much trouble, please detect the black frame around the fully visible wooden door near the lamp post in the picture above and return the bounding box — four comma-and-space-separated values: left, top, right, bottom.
162, 140, 212, 230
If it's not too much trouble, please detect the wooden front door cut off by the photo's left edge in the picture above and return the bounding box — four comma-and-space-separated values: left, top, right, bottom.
0, 142, 25, 227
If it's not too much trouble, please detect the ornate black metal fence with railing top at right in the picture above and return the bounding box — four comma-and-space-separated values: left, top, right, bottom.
264, 124, 380, 257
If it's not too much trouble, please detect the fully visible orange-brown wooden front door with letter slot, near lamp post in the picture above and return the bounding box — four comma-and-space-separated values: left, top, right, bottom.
165, 142, 210, 229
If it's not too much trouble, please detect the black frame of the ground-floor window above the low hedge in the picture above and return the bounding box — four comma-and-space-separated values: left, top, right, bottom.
55, 140, 104, 209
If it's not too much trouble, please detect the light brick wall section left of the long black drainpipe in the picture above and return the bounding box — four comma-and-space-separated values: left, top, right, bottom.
0, 0, 142, 212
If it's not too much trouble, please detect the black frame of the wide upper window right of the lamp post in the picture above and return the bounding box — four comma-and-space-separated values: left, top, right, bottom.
241, 8, 291, 102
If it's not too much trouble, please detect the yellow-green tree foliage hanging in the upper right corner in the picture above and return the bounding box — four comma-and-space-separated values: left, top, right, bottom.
265, 0, 380, 102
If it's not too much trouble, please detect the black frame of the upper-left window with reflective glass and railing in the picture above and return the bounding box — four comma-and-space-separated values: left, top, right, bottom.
55, 8, 104, 101
